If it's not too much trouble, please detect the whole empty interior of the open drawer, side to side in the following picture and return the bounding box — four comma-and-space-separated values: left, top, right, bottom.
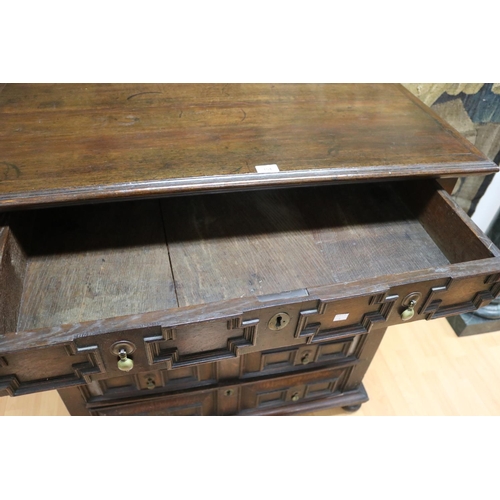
0, 181, 498, 332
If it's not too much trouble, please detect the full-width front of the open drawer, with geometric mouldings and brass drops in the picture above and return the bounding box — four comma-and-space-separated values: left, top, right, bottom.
0, 265, 500, 395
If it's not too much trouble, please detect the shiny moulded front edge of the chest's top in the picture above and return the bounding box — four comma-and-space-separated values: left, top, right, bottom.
0, 161, 499, 211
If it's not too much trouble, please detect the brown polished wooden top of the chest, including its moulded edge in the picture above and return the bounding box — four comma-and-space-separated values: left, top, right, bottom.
0, 84, 497, 208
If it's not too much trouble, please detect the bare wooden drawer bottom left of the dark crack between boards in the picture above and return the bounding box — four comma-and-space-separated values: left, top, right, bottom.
11, 201, 177, 331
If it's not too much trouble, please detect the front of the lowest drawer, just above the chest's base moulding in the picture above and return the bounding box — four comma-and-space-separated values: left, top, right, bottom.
88, 368, 349, 416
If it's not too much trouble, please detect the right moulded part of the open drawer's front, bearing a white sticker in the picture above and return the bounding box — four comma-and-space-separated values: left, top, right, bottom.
295, 273, 500, 344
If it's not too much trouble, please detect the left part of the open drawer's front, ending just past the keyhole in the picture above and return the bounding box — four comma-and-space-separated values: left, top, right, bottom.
0, 295, 313, 396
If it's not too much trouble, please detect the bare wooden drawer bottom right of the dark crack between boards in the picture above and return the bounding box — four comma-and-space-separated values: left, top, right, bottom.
162, 180, 449, 305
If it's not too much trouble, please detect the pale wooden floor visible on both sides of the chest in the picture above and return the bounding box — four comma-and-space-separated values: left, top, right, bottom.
0, 319, 500, 416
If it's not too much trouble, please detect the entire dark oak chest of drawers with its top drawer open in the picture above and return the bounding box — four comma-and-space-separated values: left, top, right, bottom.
0, 84, 500, 415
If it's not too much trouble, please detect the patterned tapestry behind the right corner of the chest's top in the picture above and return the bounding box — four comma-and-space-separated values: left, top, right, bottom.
403, 83, 500, 215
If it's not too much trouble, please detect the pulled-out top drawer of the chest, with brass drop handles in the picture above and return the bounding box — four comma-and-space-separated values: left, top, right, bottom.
0, 180, 500, 395
